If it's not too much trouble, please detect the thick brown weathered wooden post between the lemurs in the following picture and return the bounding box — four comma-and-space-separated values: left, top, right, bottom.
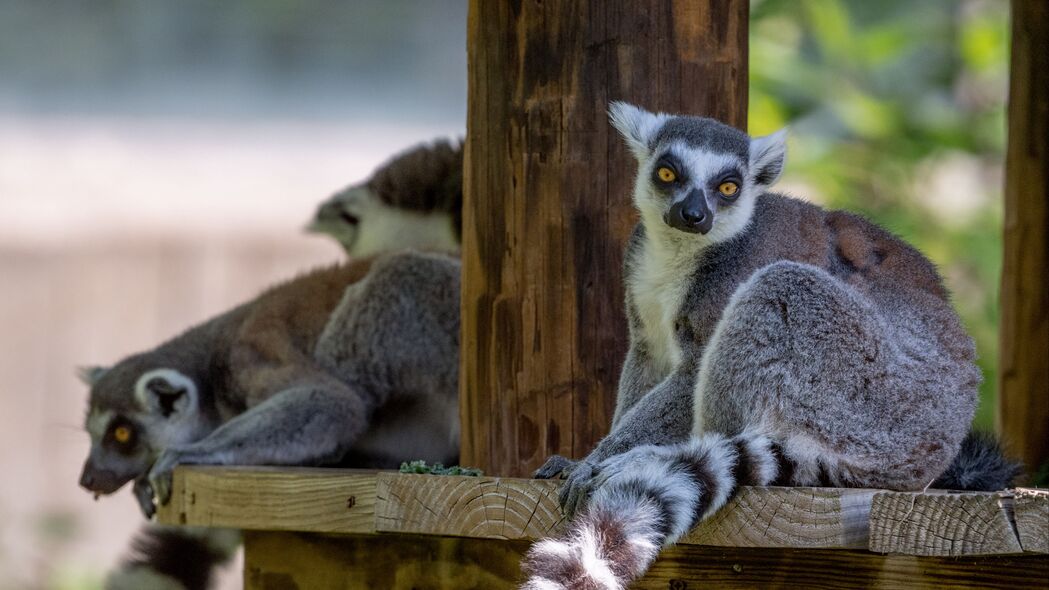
459, 0, 748, 476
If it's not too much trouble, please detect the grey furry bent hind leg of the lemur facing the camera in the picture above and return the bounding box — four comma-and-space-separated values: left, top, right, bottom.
694, 261, 971, 489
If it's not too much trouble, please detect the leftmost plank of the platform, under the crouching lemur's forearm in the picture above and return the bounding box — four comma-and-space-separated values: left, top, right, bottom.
156, 466, 376, 532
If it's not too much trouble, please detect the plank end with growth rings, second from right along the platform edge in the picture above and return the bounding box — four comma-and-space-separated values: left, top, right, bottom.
871, 491, 1023, 555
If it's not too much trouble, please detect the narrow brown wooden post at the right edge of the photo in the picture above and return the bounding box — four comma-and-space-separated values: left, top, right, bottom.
998, 0, 1049, 471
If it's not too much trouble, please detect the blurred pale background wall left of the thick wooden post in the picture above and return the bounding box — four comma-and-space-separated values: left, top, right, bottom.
0, 0, 466, 589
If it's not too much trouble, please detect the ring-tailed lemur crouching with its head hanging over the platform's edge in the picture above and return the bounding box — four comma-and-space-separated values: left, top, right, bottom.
80, 252, 461, 588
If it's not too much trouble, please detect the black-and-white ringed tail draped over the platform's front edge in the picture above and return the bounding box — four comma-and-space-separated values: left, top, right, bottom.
522, 426, 787, 590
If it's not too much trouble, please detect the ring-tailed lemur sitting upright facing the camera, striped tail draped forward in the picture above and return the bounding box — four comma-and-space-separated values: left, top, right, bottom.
525, 103, 1008, 589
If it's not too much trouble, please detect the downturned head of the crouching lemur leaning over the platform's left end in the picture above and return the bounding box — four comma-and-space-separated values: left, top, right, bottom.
80, 355, 214, 494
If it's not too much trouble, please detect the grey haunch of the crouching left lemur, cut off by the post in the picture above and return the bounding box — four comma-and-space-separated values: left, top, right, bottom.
315, 252, 461, 465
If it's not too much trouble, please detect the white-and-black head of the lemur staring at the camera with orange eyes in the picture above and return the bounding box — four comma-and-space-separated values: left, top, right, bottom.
608, 102, 787, 244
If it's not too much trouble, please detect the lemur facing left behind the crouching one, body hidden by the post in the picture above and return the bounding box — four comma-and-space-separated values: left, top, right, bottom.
306, 140, 463, 256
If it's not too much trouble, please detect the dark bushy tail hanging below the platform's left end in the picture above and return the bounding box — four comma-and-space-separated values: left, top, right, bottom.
105, 525, 240, 590
